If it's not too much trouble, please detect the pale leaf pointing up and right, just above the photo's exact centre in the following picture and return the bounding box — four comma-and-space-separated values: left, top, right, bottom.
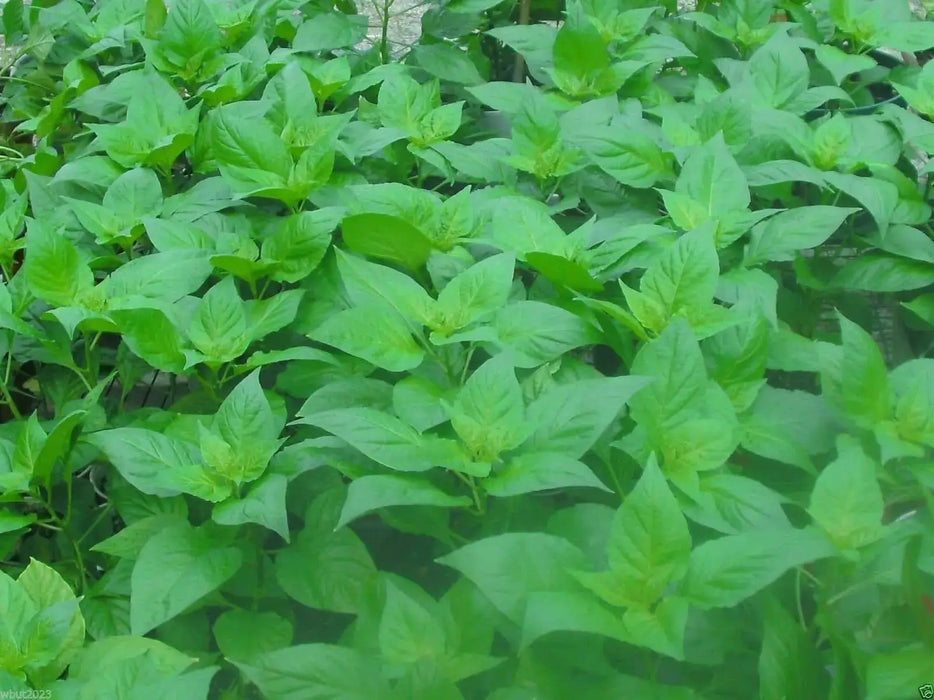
435, 253, 516, 335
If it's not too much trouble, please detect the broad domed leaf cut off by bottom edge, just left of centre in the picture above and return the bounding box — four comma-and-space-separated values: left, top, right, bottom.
234, 644, 392, 700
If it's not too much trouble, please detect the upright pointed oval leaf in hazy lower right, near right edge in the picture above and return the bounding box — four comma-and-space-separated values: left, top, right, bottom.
808, 436, 885, 549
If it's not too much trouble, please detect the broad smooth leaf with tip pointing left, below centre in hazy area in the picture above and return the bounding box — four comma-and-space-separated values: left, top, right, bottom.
437, 533, 584, 624
